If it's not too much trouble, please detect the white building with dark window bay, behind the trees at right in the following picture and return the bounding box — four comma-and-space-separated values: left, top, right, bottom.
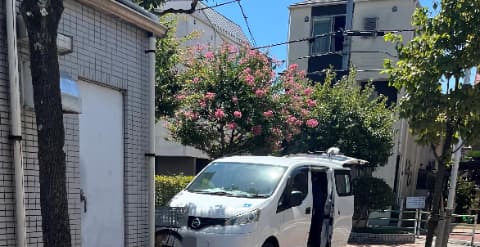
288, 0, 435, 200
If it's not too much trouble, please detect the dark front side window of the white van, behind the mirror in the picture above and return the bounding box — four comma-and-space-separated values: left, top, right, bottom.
277, 167, 308, 213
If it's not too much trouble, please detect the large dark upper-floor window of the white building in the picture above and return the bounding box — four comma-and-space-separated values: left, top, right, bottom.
311, 16, 346, 55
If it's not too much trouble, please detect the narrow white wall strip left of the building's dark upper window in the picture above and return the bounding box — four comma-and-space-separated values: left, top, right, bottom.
288, 6, 312, 71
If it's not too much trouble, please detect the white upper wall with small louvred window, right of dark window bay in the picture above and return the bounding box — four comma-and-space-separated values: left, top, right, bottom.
350, 0, 416, 81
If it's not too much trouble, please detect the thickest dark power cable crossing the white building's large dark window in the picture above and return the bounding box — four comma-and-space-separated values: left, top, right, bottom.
251, 29, 416, 50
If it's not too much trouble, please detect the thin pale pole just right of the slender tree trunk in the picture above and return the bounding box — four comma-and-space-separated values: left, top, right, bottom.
435, 138, 463, 247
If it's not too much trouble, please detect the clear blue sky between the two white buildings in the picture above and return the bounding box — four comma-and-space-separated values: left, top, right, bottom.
213, 0, 433, 67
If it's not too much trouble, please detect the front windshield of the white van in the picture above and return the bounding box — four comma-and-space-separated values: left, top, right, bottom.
187, 162, 286, 198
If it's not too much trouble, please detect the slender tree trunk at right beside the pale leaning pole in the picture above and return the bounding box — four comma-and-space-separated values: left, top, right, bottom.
425, 125, 453, 247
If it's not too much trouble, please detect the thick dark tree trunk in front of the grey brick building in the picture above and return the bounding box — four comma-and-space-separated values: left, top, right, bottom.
20, 0, 71, 247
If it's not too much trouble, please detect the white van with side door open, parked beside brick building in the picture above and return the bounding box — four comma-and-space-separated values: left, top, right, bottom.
156, 154, 359, 247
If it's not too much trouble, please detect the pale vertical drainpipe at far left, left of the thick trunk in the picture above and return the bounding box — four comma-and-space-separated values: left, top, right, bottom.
5, 0, 26, 247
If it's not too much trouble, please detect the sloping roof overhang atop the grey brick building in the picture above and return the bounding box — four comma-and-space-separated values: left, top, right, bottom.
77, 0, 167, 38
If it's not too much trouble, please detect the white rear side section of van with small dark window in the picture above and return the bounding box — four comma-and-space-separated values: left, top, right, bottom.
332, 170, 354, 247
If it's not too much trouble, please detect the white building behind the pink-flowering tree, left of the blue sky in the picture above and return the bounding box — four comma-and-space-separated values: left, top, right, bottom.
155, 0, 249, 175
